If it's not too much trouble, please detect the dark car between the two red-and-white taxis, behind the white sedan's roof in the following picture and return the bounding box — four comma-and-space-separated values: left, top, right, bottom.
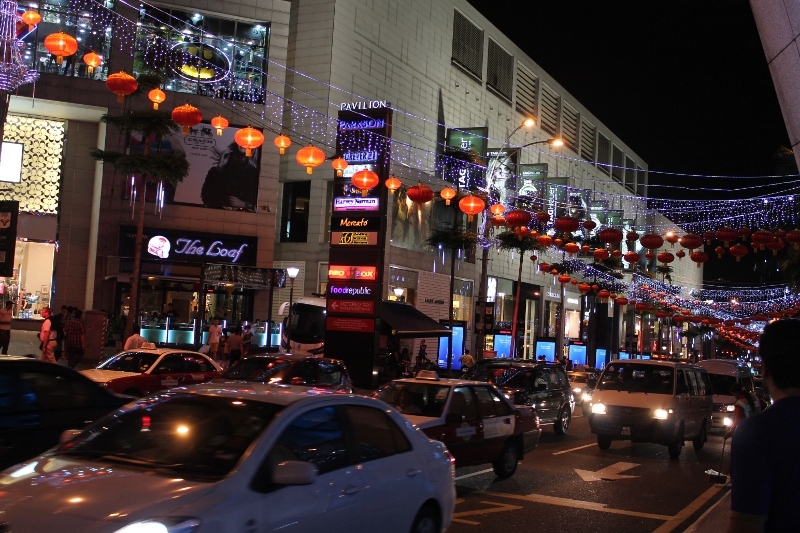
220, 354, 353, 393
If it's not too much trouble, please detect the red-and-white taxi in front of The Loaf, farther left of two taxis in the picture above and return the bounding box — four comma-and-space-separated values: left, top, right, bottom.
81, 343, 222, 397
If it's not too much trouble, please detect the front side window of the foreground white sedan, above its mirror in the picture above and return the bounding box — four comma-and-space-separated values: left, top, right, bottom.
269, 407, 347, 474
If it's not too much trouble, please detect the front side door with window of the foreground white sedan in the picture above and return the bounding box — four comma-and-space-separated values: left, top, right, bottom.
260, 406, 362, 533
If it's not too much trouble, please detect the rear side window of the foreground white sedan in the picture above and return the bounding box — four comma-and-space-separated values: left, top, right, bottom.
346, 405, 411, 463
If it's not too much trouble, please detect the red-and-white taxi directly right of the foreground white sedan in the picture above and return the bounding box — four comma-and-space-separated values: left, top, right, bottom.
374, 370, 541, 478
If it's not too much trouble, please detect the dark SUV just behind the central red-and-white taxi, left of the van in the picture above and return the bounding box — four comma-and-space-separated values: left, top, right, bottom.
464, 359, 575, 435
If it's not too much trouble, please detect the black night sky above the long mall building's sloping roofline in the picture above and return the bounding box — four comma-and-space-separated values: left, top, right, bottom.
469, 0, 789, 198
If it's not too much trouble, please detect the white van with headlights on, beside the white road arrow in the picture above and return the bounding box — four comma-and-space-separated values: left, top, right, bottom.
589, 360, 712, 459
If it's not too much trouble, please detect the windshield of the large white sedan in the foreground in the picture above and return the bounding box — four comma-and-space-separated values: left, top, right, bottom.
53, 393, 283, 481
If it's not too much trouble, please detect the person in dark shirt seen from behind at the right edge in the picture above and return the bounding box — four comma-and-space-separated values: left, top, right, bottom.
728, 320, 800, 533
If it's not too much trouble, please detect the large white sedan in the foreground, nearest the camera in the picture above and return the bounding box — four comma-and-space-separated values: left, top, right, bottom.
0, 383, 455, 533
